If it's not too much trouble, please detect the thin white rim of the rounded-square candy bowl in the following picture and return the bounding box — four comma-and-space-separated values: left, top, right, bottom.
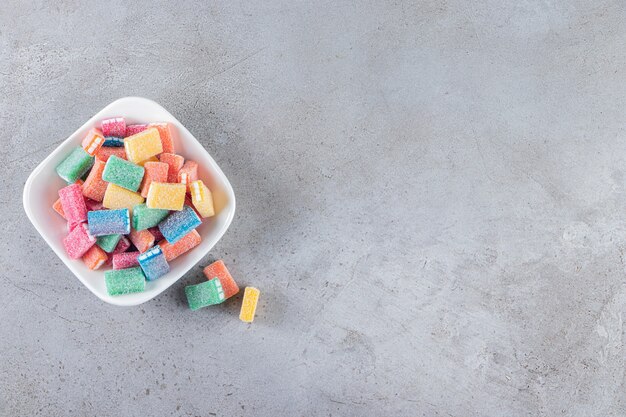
22, 96, 237, 307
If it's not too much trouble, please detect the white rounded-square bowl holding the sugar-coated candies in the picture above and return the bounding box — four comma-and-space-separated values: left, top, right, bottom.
24, 97, 235, 306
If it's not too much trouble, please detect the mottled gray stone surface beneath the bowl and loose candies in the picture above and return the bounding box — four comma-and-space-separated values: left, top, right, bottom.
0, 0, 626, 417
